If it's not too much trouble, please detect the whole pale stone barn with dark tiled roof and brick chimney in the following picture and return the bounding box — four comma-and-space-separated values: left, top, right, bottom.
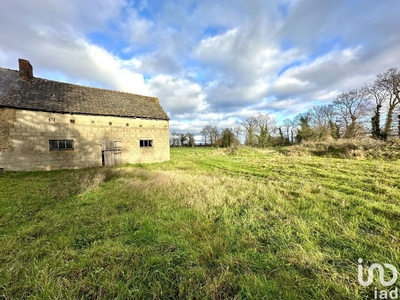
0, 59, 170, 171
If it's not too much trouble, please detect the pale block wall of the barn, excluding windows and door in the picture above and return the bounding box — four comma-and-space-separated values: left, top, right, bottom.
0, 109, 170, 171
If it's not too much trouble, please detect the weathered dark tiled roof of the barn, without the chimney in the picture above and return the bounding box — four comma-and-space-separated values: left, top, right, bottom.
0, 68, 169, 120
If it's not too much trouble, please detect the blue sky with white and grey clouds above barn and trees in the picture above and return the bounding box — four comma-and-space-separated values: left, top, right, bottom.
0, 0, 400, 133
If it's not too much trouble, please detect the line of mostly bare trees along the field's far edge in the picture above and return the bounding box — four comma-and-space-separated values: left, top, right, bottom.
170, 68, 400, 147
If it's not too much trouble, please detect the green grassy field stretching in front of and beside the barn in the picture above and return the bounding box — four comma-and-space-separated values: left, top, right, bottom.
0, 148, 400, 299
